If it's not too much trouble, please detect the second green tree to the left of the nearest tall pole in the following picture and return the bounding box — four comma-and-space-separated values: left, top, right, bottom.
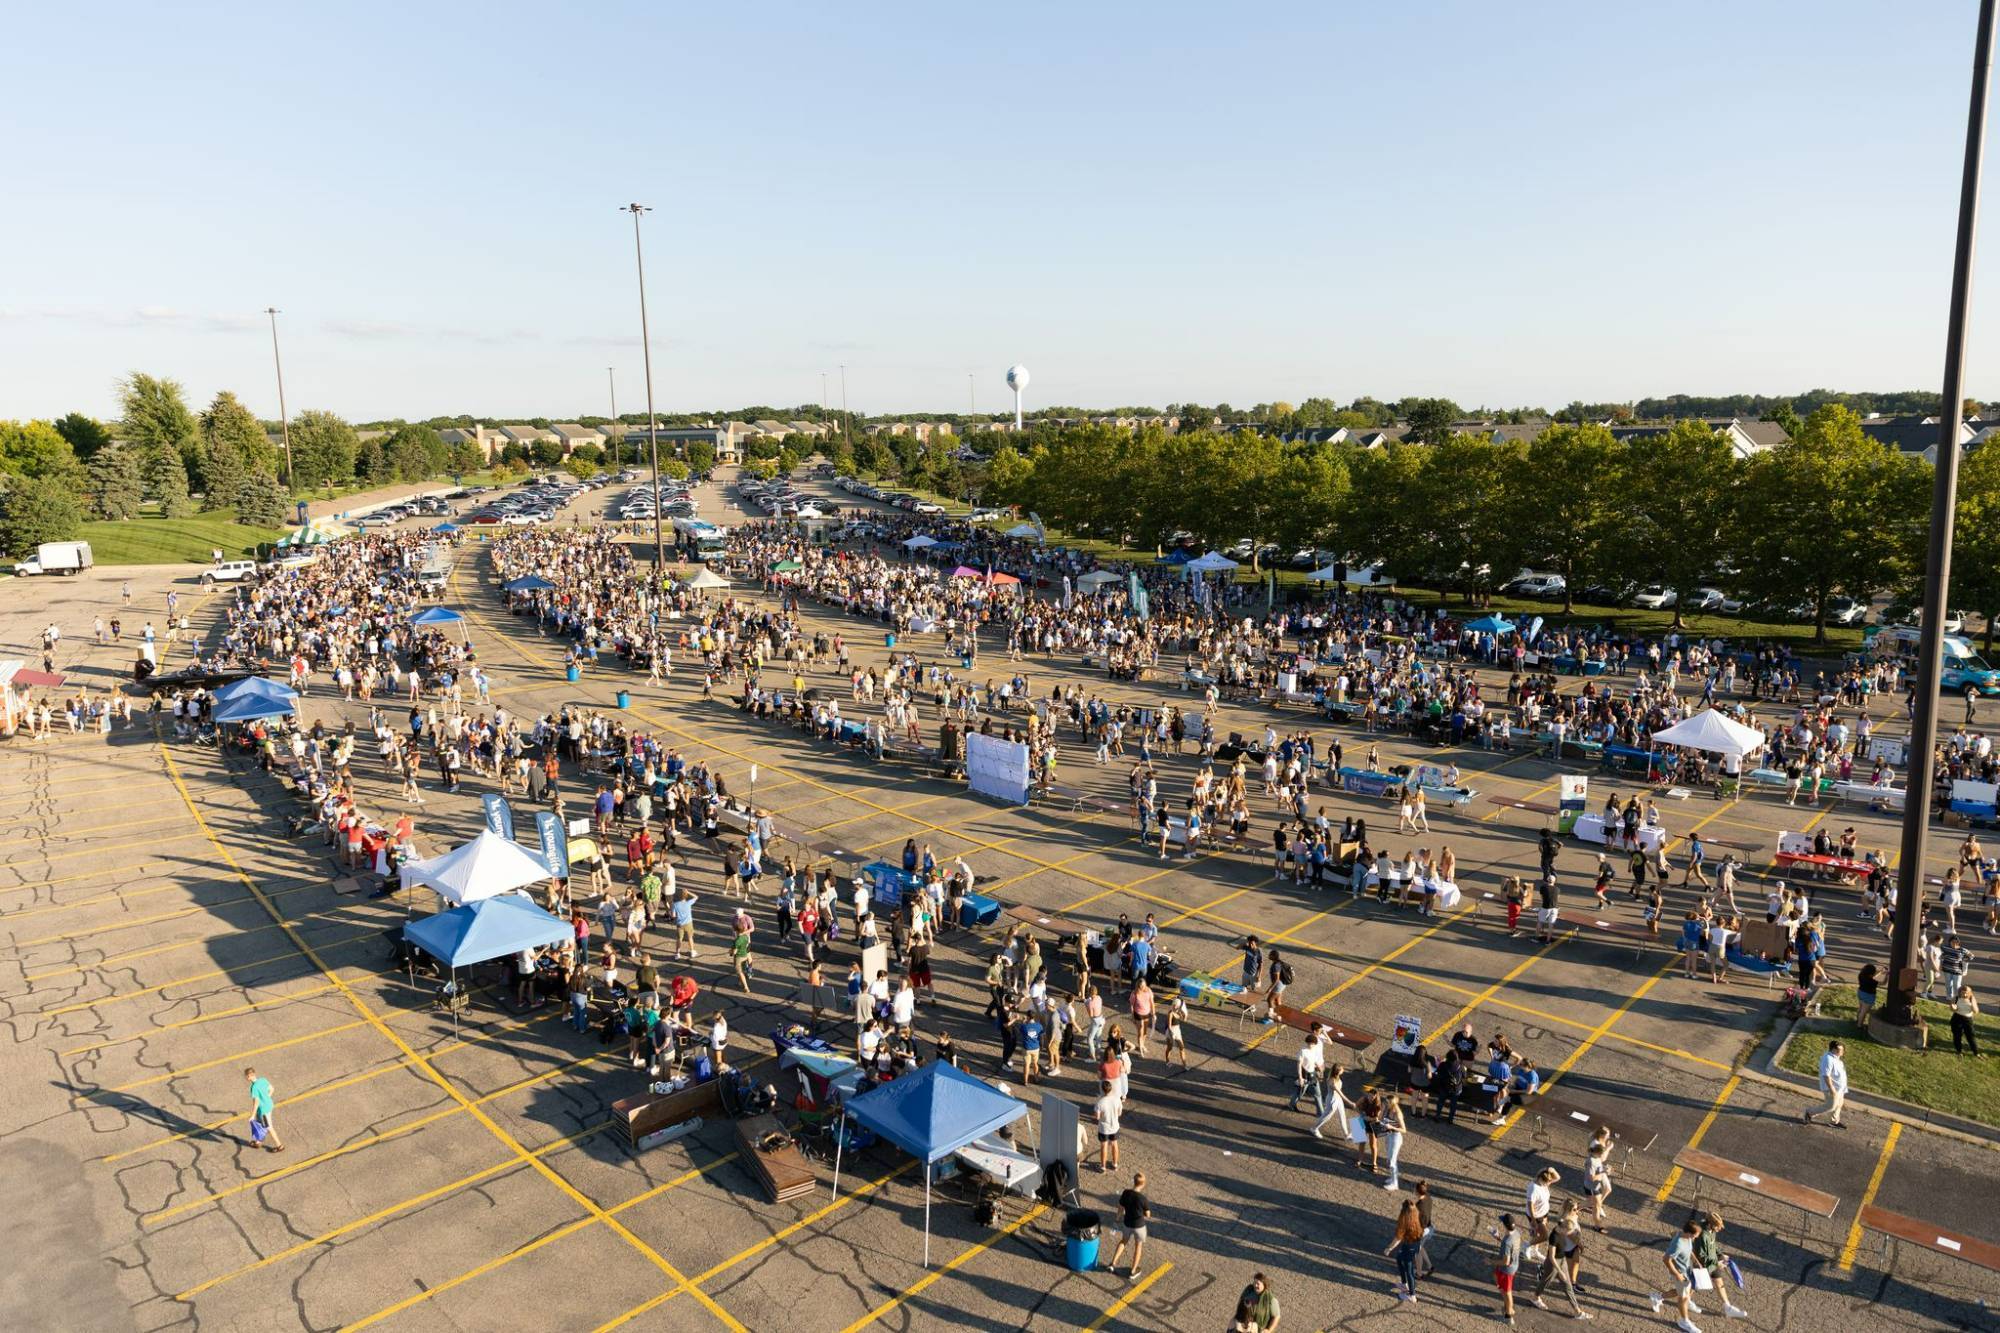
1614, 420, 1744, 626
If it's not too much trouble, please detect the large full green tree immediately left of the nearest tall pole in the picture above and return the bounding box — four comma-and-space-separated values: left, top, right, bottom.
1742, 404, 1928, 642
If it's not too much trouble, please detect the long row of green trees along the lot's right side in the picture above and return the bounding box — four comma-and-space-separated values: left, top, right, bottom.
964, 404, 2000, 634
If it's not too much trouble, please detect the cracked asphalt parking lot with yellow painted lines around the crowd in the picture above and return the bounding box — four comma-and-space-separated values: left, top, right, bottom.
0, 472, 2000, 1331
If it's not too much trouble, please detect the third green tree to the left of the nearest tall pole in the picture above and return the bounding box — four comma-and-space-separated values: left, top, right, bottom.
1506, 424, 1620, 610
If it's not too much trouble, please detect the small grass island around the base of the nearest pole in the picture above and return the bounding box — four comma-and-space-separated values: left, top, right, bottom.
1778, 987, 2000, 1125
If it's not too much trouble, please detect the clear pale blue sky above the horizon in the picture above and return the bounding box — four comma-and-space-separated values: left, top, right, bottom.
0, 0, 2000, 418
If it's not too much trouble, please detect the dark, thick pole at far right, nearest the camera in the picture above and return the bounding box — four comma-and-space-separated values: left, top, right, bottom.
1880, 0, 1994, 1045
